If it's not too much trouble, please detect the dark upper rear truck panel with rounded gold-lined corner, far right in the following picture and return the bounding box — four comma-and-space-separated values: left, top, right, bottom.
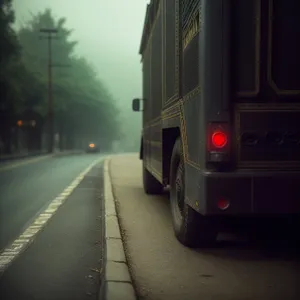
268, 0, 300, 95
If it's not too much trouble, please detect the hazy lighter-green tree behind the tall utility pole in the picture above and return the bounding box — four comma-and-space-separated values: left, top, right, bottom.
18, 9, 119, 151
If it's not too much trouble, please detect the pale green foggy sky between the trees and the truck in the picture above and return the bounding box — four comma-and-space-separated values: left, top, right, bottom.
13, 0, 149, 110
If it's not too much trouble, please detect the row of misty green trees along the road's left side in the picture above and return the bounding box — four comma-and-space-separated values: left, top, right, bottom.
0, 0, 121, 153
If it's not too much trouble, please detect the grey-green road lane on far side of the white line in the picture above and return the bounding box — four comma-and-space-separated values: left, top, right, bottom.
0, 155, 101, 250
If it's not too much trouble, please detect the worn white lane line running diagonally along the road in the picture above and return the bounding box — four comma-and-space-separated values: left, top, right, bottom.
0, 158, 104, 272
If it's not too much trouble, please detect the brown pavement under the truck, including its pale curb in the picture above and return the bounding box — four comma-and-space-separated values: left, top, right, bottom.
104, 154, 300, 300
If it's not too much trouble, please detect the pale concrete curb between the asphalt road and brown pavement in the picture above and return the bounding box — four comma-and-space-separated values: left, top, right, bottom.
99, 157, 137, 300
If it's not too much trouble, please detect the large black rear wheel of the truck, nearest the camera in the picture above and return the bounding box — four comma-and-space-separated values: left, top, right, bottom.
170, 138, 217, 248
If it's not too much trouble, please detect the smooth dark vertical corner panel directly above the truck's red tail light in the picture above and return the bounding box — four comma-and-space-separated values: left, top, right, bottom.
199, 0, 232, 119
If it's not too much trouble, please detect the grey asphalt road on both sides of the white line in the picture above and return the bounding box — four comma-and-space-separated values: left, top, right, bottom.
0, 154, 103, 300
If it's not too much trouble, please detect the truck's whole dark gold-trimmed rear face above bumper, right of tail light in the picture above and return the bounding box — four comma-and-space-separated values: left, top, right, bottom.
232, 0, 300, 169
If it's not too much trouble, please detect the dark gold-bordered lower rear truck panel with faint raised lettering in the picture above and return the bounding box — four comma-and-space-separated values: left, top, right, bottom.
236, 105, 300, 169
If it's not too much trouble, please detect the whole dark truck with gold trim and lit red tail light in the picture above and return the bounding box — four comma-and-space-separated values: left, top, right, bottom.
132, 0, 300, 247
